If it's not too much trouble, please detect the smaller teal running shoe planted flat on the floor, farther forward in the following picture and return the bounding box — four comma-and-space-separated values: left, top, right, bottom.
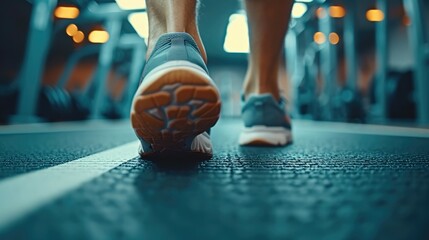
239, 94, 292, 146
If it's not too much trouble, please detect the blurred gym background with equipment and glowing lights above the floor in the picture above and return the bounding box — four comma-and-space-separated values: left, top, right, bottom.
0, 0, 429, 126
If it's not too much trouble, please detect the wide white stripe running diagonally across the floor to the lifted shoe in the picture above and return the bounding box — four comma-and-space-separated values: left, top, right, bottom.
0, 141, 138, 231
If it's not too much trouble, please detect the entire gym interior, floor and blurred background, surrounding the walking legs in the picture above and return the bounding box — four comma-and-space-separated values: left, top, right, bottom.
0, 0, 429, 240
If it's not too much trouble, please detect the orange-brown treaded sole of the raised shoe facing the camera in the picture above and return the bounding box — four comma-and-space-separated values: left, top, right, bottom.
131, 61, 221, 155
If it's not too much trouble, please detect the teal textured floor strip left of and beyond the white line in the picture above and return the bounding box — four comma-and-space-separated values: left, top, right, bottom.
0, 124, 136, 180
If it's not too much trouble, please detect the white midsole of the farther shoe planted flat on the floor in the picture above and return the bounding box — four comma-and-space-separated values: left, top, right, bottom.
238, 126, 292, 146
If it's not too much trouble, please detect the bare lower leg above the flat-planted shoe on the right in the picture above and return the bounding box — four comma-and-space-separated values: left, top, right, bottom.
243, 0, 293, 99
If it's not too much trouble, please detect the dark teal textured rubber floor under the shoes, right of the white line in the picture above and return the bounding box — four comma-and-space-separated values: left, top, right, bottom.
0, 119, 429, 240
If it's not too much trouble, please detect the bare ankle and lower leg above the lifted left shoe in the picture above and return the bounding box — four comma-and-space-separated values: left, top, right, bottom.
146, 0, 207, 62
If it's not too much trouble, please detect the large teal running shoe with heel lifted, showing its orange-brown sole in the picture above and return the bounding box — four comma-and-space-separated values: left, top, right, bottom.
131, 33, 221, 158
